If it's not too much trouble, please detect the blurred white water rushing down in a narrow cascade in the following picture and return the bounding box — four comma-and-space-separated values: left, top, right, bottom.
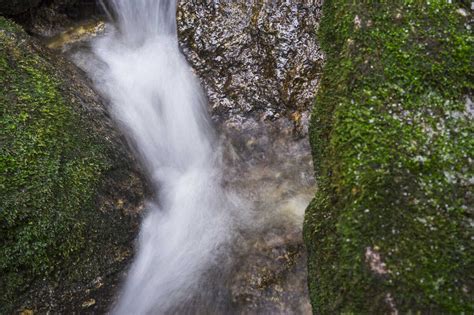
94, 0, 241, 315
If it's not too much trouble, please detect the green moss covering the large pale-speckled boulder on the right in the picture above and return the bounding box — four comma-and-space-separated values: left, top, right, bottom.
304, 0, 474, 313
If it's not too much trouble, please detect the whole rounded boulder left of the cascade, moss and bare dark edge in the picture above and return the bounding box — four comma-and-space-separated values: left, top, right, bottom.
0, 17, 144, 313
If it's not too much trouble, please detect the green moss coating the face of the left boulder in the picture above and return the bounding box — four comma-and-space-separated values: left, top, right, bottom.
0, 18, 110, 313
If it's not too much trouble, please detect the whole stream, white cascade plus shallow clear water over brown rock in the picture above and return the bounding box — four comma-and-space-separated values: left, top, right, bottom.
70, 0, 313, 315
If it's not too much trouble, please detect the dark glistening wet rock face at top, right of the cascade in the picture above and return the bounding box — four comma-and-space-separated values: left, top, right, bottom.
178, 0, 323, 132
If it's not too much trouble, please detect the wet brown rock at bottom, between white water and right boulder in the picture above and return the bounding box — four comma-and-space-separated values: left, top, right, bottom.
229, 224, 311, 314
